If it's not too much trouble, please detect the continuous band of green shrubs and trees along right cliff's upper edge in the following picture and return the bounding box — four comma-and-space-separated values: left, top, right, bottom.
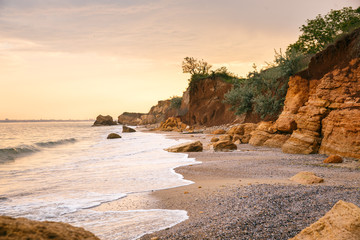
225, 7, 360, 118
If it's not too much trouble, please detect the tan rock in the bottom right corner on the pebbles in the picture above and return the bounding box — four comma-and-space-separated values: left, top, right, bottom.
289, 200, 360, 240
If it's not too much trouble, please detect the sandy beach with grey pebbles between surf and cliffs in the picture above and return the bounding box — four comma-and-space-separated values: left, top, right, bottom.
96, 132, 360, 239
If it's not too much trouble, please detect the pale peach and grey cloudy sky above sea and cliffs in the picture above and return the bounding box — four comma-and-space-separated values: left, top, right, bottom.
0, 0, 360, 119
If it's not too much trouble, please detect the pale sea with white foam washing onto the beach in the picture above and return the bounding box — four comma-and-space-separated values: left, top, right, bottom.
0, 121, 197, 240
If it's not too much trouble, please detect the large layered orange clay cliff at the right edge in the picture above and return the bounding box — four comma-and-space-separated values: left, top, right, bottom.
250, 29, 360, 158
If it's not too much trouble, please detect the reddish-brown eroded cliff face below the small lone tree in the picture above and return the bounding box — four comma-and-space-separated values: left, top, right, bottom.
181, 78, 237, 126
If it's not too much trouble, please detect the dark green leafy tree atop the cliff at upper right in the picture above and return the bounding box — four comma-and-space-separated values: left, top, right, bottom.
288, 7, 360, 54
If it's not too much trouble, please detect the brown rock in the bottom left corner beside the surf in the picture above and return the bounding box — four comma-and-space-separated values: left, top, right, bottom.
0, 216, 100, 240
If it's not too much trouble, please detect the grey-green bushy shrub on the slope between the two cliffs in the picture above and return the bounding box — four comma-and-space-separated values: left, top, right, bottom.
224, 51, 309, 118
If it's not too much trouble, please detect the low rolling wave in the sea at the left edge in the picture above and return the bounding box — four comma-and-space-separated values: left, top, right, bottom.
0, 138, 76, 163
